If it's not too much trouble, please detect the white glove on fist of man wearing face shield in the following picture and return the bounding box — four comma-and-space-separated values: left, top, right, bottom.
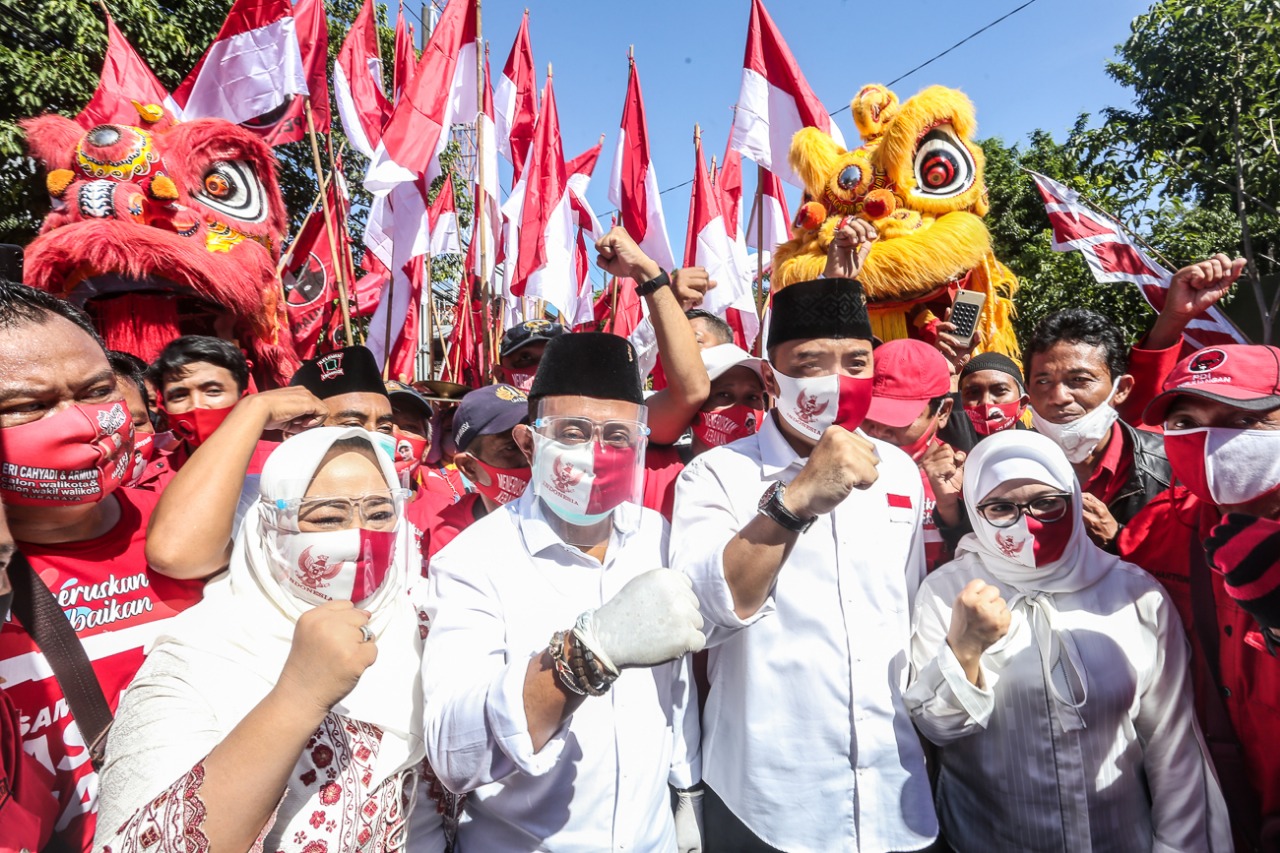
576, 569, 707, 669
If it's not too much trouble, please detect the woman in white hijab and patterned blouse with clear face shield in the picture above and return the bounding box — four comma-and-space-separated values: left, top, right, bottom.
95, 427, 443, 853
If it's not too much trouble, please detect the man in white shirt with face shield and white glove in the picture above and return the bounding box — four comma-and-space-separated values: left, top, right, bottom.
424, 333, 704, 853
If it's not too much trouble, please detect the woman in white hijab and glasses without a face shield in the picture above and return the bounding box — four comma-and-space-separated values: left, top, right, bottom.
904, 430, 1231, 853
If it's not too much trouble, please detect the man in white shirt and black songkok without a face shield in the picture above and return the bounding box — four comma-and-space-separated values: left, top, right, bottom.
671, 278, 937, 853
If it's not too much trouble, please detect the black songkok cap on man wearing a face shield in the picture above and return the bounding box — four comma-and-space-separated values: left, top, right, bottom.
529, 332, 644, 406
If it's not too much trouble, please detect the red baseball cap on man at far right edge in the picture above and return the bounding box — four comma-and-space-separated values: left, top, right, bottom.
1142, 343, 1280, 427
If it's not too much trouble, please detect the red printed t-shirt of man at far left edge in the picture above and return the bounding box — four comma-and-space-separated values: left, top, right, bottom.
0, 489, 205, 850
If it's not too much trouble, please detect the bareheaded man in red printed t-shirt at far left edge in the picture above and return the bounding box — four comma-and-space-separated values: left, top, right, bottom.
0, 286, 204, 850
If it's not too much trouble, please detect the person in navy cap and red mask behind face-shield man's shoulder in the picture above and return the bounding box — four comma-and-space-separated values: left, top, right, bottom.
408, 384, 530, 558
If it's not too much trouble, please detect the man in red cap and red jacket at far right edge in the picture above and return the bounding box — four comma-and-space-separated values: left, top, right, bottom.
1119, 346, 1280, 850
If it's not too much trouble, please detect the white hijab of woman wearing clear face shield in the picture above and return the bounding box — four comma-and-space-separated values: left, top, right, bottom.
156, 427, 425, 786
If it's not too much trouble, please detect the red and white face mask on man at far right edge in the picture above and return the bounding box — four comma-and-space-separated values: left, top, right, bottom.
1165, 427, 1280, 506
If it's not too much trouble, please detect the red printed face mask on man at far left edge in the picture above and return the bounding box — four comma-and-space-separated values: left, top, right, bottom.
0, 402, 133, 506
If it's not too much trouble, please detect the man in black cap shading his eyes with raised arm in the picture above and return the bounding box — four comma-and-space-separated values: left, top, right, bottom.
147, 346, 396, 576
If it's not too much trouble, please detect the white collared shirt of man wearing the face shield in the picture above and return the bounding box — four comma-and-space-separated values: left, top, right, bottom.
424, 491, 701, 852
